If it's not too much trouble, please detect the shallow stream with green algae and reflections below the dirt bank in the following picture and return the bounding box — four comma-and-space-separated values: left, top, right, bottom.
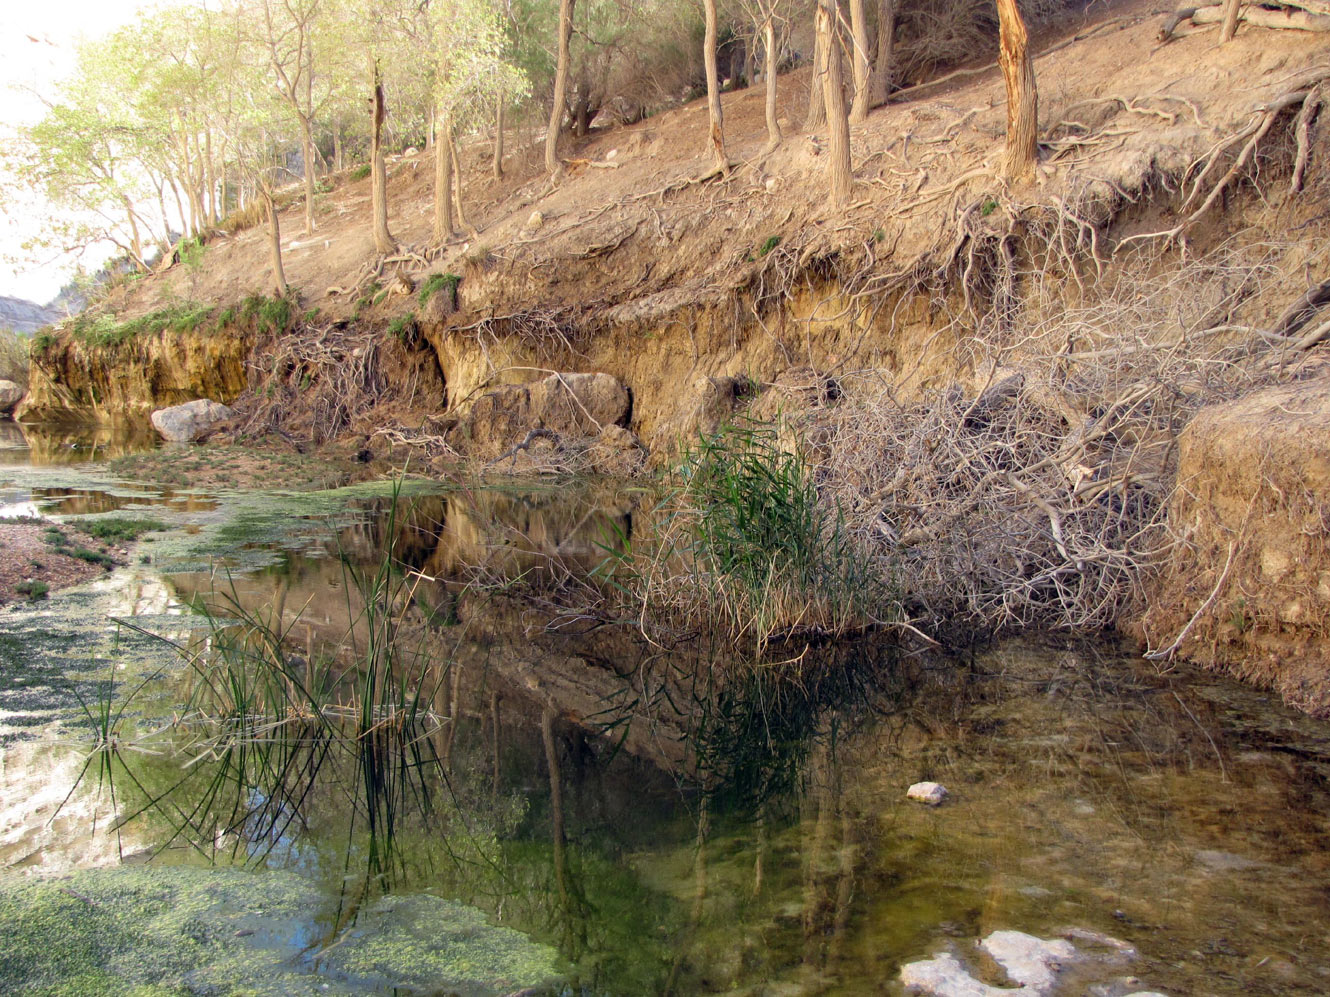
0, 422, 1330, 997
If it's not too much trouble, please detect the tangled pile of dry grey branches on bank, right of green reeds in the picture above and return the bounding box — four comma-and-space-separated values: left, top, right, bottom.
819, 233, 1330, 637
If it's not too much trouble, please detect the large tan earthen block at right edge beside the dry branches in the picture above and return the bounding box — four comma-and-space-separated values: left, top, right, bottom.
1132, 375, 1330, 714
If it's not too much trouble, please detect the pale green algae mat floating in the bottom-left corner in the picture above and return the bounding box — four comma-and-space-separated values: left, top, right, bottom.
0, 867, 556, 997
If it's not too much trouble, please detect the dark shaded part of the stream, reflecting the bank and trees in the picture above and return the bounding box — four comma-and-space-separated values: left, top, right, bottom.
2, 481, 1330, 994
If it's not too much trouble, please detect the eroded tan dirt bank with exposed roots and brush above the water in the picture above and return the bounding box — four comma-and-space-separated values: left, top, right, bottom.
15, 4, 1330, 710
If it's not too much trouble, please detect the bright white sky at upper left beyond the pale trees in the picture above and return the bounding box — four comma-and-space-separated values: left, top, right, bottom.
0, 0, 145, 303
